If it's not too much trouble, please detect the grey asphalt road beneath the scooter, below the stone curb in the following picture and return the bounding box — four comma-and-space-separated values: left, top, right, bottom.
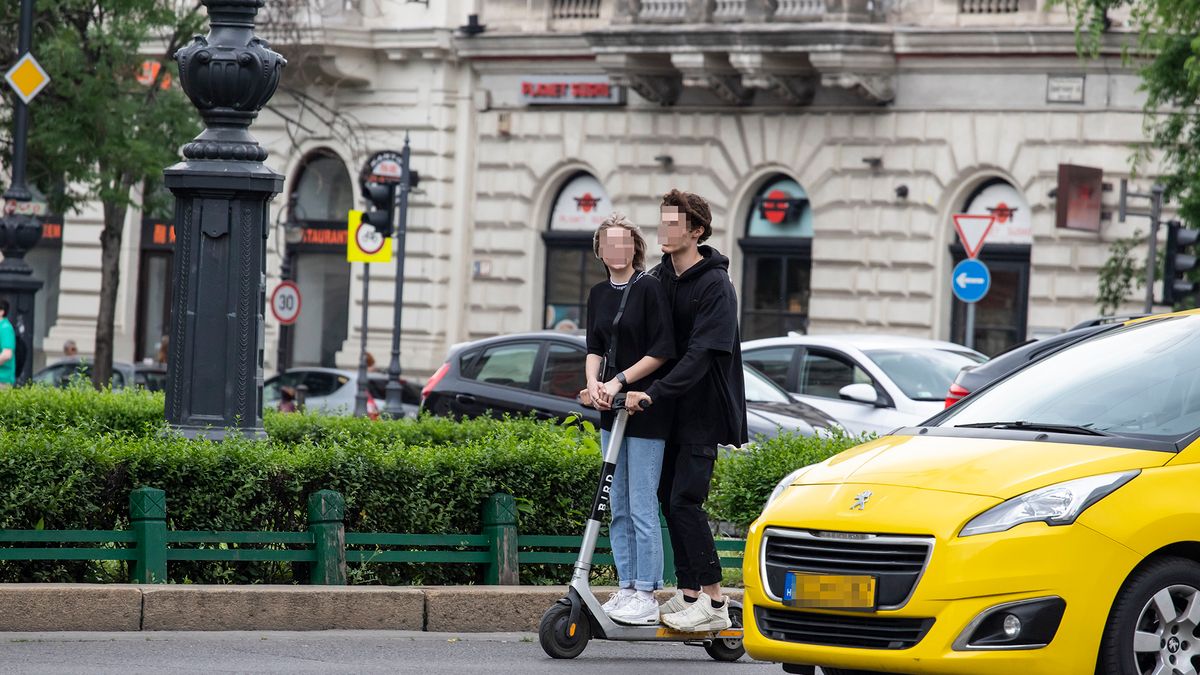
0, 631, 782, 675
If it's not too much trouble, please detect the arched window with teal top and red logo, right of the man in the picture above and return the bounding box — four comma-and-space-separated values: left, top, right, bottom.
740, 174, 812, 340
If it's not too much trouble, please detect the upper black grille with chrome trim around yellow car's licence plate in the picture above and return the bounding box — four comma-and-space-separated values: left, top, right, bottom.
762, 527, 934, 609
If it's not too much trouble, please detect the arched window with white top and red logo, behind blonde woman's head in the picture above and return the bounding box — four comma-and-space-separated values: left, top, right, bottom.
542, 172, 613, 330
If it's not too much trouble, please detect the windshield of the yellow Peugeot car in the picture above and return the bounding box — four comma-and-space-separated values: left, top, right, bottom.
937, 315, 1200, 443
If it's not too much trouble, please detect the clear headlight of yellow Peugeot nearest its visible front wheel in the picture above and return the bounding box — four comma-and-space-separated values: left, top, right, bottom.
959, 471, 1141, 537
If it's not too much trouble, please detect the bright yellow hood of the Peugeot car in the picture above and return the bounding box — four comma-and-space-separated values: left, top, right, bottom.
796, 436, 1175, 500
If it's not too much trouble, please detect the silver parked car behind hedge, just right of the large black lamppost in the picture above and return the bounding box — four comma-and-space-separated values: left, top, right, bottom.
263, 368, 421, 417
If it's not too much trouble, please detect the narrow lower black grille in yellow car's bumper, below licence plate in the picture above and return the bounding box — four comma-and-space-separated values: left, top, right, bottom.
754, 607, 934, 650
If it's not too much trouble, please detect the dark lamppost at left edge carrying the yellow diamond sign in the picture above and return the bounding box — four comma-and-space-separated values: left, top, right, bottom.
0, 0, 42, 382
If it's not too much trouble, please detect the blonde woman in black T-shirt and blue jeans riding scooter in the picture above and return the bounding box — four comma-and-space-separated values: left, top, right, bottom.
584, 214, 674, 626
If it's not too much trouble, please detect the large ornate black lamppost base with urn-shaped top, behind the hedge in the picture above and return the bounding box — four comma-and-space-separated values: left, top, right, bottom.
163, 0, 286, 438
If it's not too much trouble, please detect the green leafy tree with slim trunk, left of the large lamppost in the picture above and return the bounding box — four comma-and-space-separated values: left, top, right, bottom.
0, 0, 205, 382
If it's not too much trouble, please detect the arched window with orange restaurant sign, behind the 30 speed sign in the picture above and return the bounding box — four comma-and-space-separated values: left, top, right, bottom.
280, 151, 354, 370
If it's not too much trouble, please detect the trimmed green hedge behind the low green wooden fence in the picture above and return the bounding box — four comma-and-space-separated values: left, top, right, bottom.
0, 388, 851, 584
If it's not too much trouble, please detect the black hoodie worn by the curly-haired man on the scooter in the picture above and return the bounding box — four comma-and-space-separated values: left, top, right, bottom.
646, 246, 749, 444
